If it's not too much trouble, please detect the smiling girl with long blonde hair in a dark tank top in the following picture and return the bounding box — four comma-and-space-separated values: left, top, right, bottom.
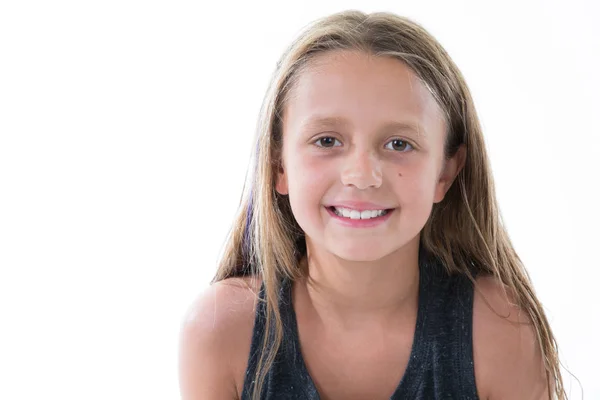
180, 11, 565, 400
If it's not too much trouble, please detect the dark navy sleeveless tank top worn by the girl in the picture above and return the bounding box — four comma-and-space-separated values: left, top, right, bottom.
242, 250, 478, 400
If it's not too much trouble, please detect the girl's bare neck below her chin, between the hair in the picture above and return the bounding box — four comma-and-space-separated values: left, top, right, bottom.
298, 236, 420, 331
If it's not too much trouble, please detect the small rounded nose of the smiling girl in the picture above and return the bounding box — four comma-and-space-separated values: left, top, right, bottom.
342, 151, 383, 189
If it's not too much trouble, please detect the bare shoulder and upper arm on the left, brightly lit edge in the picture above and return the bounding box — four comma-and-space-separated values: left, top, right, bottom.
179, 277, 262, 400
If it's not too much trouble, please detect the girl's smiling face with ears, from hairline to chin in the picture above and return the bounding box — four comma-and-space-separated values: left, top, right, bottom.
276, 51, 464, 261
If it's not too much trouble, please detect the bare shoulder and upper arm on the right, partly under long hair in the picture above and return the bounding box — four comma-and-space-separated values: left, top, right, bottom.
473, 276, 549, 400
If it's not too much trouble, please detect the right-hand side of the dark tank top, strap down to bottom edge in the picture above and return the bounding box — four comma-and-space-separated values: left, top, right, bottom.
390, 250, 478, 400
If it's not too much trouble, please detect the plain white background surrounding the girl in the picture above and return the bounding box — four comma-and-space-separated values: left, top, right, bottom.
0, 0, 600, 400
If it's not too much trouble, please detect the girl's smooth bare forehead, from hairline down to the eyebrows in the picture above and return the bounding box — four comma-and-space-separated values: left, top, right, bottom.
284, 51, 444, 137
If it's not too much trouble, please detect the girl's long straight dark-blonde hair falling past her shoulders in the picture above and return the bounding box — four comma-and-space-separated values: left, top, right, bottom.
213, 10, 566, 399
